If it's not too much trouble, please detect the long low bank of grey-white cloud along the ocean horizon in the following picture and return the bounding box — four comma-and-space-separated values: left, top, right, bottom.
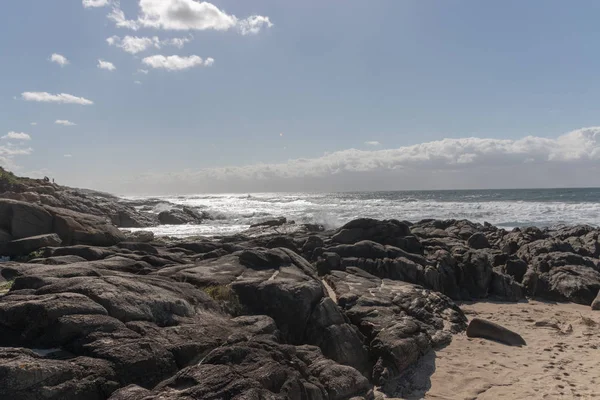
115, 127, 600, 193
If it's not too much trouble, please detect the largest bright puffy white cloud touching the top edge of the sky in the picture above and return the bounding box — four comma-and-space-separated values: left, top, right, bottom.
108, 0, 273, 35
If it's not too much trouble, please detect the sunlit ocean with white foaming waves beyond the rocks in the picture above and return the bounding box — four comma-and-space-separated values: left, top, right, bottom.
126, 188, 600, 237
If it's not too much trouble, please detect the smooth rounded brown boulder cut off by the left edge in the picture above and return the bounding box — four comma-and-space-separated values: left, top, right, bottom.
0, 199, 52, 239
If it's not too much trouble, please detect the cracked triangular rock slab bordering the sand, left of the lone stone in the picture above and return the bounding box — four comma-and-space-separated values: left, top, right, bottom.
325, 267, 466, 385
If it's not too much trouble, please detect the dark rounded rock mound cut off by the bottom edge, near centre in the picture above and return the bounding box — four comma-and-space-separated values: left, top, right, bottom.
123, 340, 370, 400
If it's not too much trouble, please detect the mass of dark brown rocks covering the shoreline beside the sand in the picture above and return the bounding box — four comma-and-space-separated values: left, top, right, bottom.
0, 170, 600, 400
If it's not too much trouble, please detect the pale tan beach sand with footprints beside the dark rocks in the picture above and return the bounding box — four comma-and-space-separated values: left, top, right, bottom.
378, 301, 600, 400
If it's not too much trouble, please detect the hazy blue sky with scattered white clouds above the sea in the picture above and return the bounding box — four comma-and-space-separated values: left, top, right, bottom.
0, 0, 600, 194
